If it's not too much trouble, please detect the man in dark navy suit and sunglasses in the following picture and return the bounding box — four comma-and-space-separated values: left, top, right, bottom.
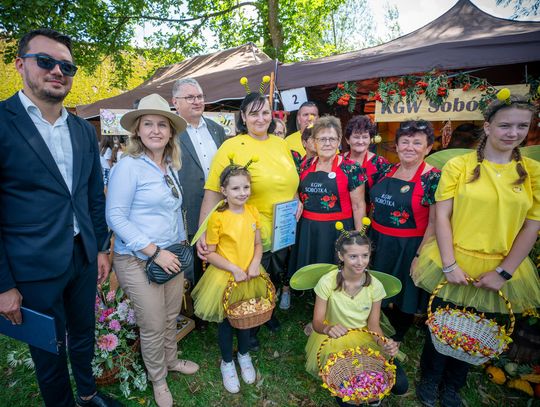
0, 29, 120, 407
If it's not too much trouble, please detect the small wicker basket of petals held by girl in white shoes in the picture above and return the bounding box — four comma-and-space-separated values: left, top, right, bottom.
223, 274, 276, 329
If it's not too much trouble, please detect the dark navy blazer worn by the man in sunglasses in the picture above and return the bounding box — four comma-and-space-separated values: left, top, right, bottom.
0, 94, 107, 292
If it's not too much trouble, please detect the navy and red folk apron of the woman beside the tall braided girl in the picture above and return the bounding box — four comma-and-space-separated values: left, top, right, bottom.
370, 163, 429, 314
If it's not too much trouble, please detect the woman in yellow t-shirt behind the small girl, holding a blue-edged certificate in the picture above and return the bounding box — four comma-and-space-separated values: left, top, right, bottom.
197, 92, 302, 350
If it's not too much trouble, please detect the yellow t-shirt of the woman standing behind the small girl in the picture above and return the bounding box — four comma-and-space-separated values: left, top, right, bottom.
204, 134, 299, 251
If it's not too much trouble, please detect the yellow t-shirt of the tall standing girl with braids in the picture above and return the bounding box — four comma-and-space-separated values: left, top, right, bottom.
435, 152, 540, 256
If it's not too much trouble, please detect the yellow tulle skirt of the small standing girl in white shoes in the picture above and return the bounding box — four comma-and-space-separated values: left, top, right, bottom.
191, 265, 266, 322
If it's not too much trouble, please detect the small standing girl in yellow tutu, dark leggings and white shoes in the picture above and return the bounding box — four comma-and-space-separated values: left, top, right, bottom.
192, 163, 266, 393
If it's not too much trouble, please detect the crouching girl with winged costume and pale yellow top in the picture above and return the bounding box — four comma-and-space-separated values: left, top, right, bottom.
306, 226, 408, 405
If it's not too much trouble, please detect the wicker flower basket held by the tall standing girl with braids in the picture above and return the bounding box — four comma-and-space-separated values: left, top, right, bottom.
426, 278, 515, 365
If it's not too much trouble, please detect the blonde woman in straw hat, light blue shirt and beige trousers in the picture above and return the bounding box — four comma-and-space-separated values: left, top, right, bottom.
106, 94, 199, 407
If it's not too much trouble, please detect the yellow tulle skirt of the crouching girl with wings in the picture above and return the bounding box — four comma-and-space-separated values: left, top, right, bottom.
306, 331, 381, 376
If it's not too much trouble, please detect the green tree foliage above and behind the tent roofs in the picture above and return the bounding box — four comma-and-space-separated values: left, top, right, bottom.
0, 0, 399, 88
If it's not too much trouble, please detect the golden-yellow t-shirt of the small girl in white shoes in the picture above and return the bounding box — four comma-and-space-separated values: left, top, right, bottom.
206, 205, 260, 270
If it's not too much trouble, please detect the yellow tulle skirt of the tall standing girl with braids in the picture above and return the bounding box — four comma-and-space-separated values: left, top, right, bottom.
412, 239, 540, 314
